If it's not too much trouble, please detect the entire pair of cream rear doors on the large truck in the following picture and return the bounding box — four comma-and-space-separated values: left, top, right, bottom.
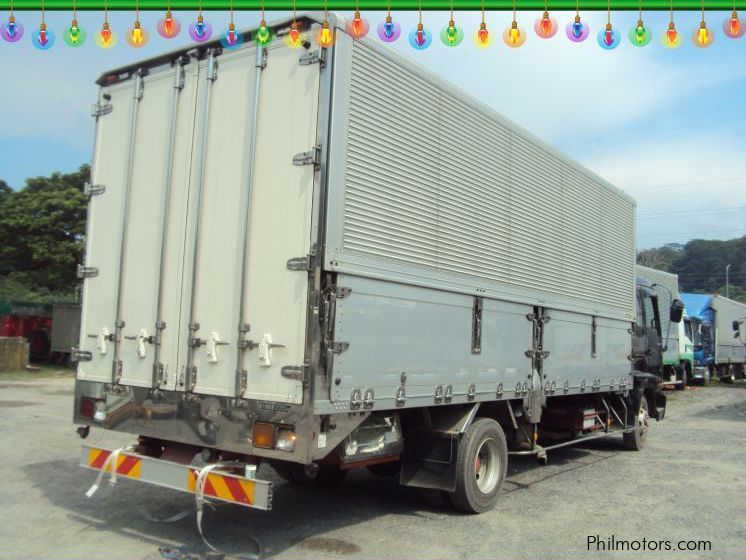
79, 44, 319, 403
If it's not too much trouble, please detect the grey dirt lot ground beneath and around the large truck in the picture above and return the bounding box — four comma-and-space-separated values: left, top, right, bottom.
0, 378, 746, 560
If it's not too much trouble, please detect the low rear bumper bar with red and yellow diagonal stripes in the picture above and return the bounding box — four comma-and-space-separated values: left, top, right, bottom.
80, 445, 272, 510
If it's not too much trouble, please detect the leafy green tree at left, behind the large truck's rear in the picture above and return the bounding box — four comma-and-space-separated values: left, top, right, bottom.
0, 165, 90, 302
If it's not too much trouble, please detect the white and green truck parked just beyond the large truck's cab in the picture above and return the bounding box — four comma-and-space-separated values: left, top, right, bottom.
637, 265, 694, 389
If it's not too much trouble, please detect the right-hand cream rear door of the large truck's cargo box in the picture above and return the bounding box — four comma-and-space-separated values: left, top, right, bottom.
181, 46, 319, 403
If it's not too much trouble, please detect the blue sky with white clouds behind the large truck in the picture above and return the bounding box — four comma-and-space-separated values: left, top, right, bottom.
0, 11, 746, 249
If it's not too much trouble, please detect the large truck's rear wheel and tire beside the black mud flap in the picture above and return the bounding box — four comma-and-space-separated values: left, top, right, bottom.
448, 418, 508, 513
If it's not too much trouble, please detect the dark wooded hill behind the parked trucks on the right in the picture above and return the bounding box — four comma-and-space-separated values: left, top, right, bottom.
637, 236, 746, 303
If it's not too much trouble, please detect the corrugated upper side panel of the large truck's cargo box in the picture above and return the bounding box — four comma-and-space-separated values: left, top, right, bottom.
330, 41, 635, 319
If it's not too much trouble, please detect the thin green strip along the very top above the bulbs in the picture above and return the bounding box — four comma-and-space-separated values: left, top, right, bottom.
5, 0, 746, 12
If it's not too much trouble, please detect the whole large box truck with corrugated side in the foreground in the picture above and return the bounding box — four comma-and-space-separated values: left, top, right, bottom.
75, 15, 682, 512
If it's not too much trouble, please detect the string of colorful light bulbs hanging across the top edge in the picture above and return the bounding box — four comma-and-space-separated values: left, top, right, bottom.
0, 0, 746, 50
